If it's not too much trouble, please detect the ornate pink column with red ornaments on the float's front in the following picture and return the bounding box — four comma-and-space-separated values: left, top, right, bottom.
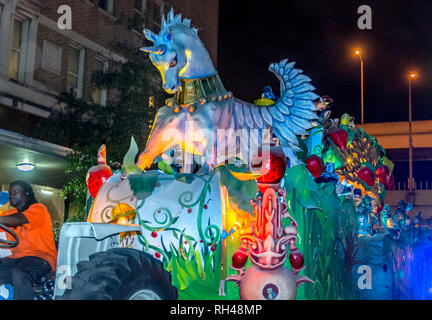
226, 138, 313, 300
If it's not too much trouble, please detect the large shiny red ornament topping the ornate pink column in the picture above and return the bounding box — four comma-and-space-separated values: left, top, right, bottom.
252, 145, 287, 184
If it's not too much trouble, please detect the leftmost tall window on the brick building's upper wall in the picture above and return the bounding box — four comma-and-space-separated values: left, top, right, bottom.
9, 19, 29, 82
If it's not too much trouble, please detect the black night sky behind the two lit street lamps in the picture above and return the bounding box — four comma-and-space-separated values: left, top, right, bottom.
218, 0, 432, 123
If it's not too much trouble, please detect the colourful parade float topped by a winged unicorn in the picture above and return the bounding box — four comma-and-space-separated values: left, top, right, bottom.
58, 10, 431, 300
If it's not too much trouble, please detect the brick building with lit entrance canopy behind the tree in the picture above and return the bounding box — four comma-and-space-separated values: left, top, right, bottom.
0, 0, 218, 222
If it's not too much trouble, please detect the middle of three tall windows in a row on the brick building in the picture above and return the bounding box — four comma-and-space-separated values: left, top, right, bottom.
66, 47, 85, 98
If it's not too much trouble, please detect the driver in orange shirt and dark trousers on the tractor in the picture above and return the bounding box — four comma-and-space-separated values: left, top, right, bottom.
0, 181, 57, 300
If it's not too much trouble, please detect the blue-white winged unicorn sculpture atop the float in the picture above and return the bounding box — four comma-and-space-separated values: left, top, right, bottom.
137, 9, 319, 171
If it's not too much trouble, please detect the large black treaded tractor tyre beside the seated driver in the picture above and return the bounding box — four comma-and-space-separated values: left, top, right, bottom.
57, 248, 177, 300
